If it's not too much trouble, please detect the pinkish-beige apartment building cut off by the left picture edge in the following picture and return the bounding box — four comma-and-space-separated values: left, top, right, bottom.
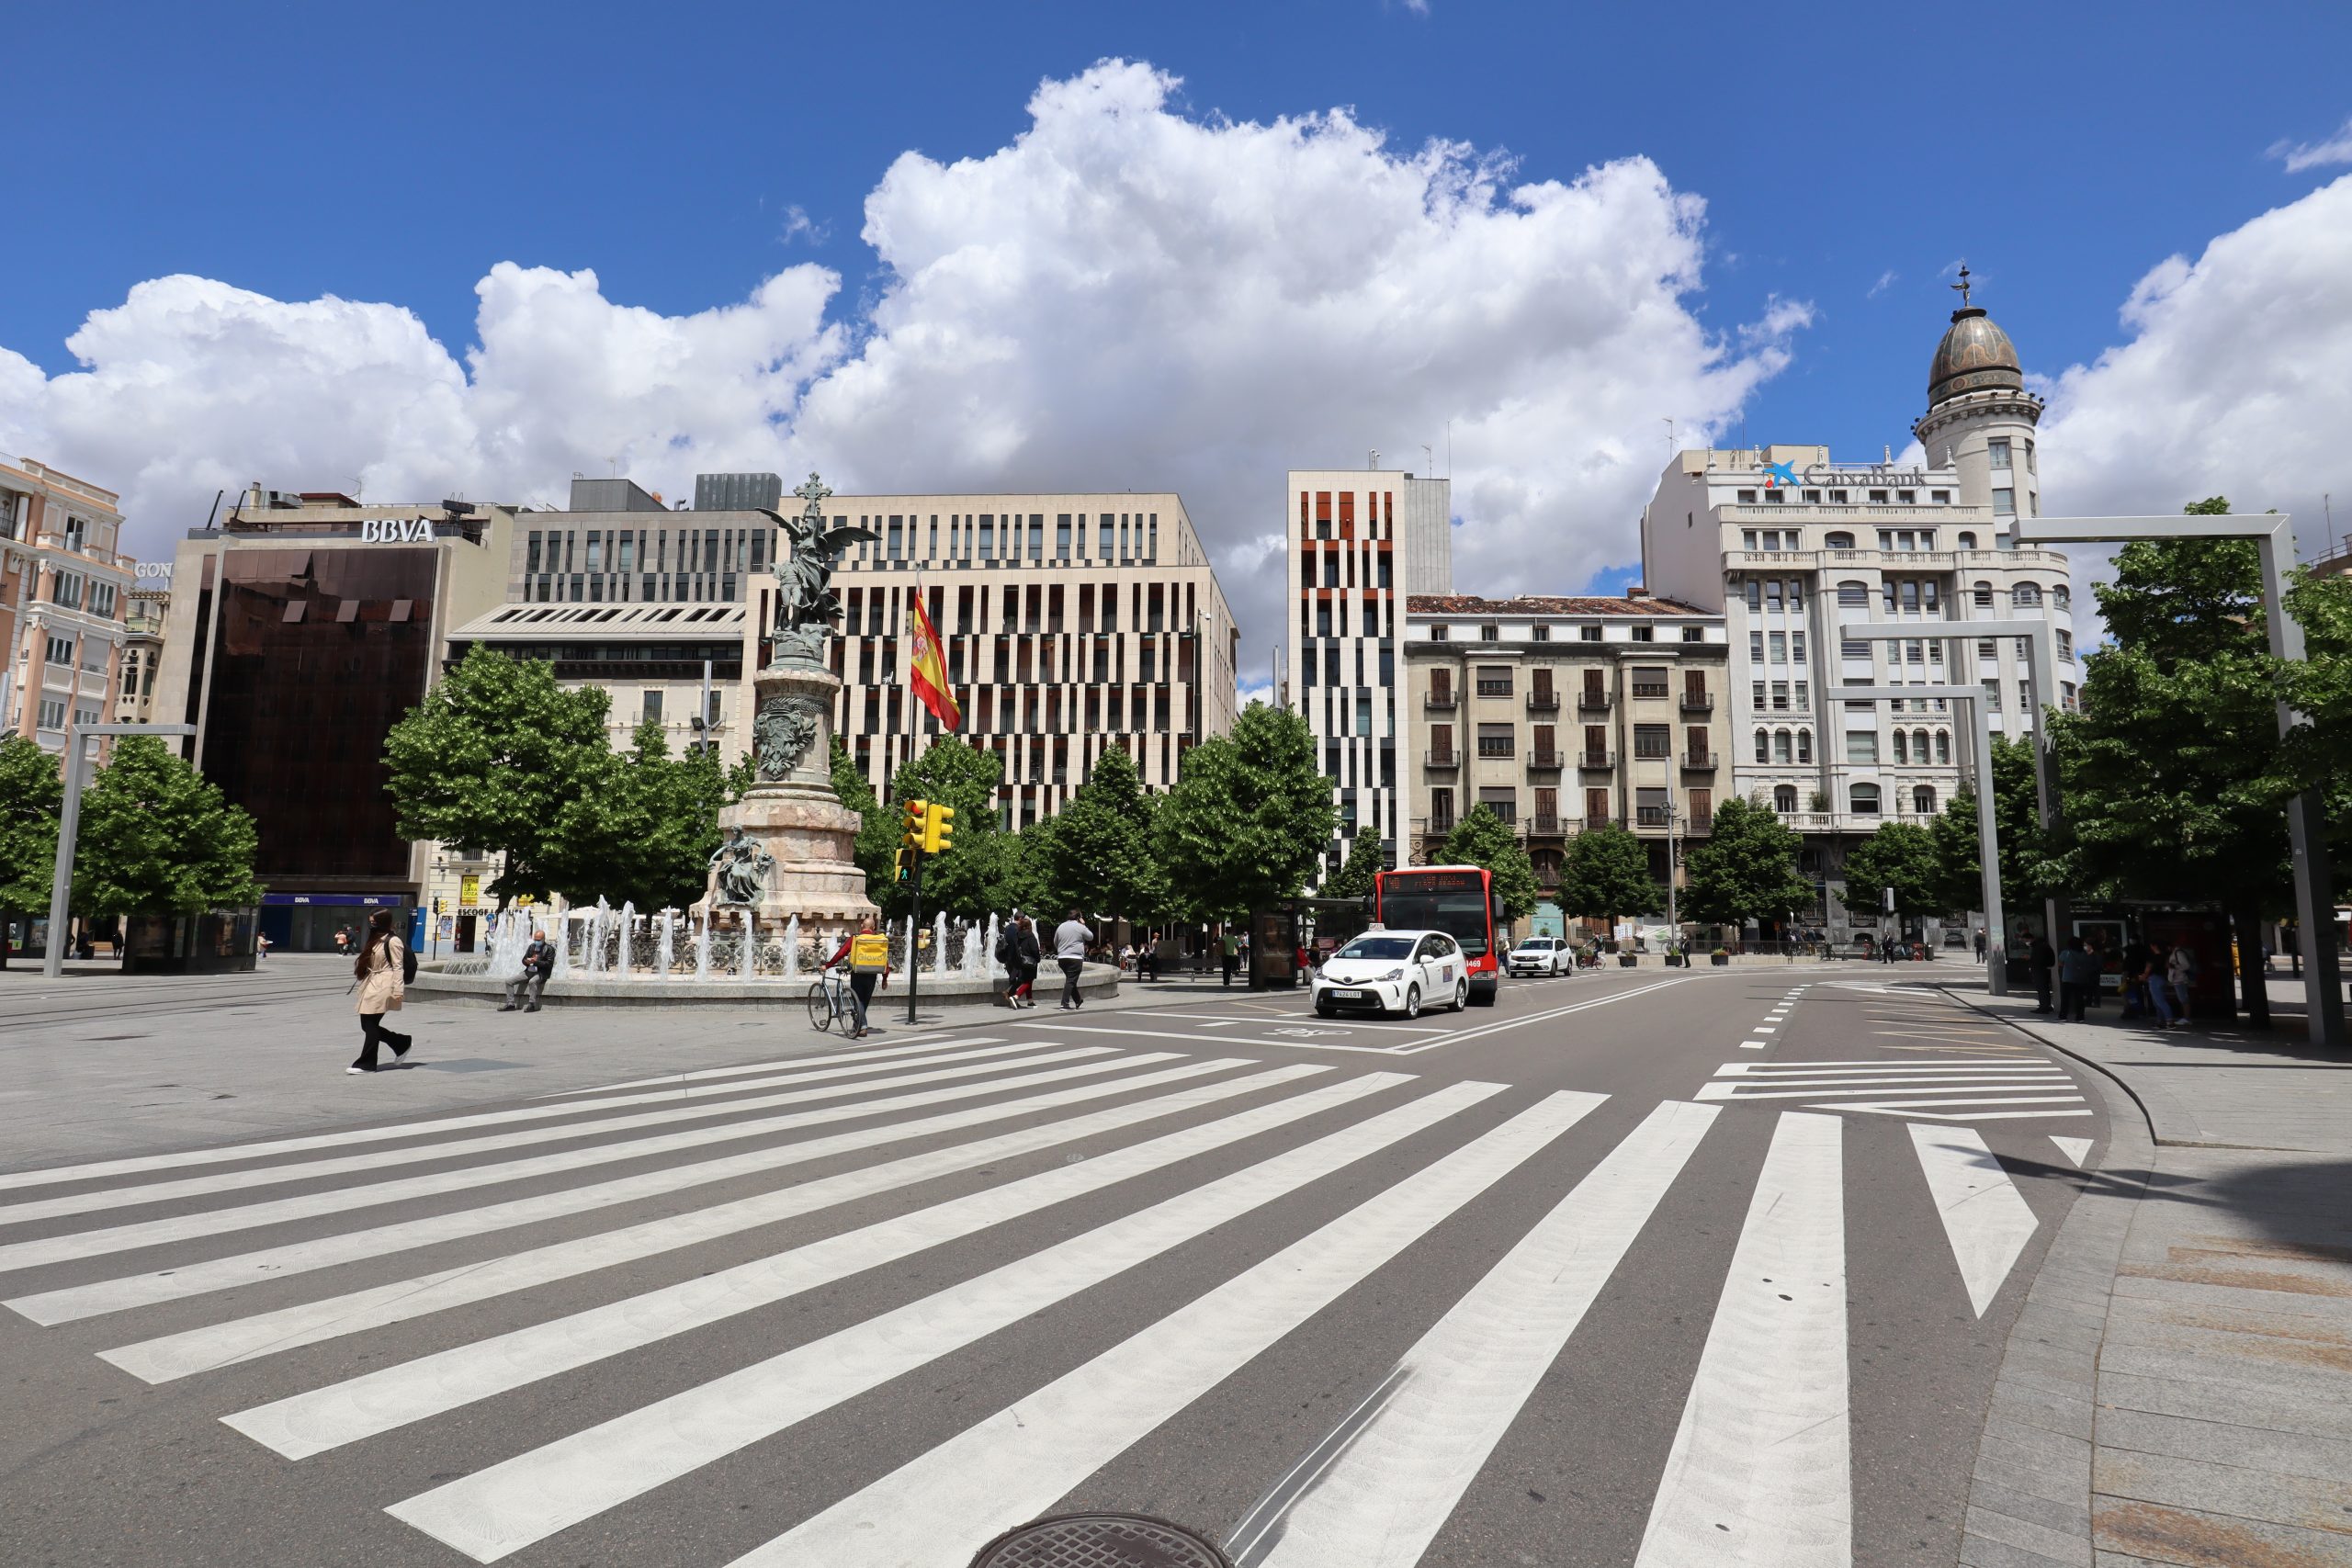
0, 458, 136, 755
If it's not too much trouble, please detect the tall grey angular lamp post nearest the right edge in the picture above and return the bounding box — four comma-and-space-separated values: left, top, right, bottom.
2016, 513, 2345, 1051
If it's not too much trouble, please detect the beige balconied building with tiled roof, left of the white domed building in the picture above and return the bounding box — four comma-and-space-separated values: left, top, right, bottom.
1399, 588, 1731, 933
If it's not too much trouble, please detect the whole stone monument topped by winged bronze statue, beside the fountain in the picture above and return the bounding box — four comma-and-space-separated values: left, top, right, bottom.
703, 472, 877, 936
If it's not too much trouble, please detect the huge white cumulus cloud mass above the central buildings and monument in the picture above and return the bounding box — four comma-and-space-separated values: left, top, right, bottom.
0, 62, 1811, 644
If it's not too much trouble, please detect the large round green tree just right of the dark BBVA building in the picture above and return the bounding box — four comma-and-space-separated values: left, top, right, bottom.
383, 644, 612, 900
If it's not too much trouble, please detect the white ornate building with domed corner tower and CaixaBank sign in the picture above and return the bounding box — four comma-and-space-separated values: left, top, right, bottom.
1642, 275, 2079, 945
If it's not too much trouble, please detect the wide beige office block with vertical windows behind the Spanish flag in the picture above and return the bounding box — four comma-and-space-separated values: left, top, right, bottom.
818, 491, 1239, 828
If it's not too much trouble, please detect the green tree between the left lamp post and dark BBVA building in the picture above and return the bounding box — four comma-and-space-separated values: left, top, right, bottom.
73, 736, 261, 915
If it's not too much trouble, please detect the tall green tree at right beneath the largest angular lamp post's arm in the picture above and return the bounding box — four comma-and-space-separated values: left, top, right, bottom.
2051, 496, 2293, 1025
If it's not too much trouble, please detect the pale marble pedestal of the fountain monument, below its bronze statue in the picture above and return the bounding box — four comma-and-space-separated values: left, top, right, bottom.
701, 663, 879, 938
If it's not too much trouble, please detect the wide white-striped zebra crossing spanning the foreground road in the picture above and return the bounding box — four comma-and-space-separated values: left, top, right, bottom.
0, 1034, 2075, 1568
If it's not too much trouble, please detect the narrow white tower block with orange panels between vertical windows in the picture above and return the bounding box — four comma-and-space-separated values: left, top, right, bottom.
1277, 468, 1453, 884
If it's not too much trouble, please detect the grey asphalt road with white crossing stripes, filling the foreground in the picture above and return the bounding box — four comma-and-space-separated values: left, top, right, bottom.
0, 964, 2105, 1568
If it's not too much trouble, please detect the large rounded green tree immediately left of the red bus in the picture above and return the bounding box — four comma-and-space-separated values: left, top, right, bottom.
1159, 703, 1336, 919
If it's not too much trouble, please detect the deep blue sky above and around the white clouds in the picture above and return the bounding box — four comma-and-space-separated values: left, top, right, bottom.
0, 0, 2352, 629
